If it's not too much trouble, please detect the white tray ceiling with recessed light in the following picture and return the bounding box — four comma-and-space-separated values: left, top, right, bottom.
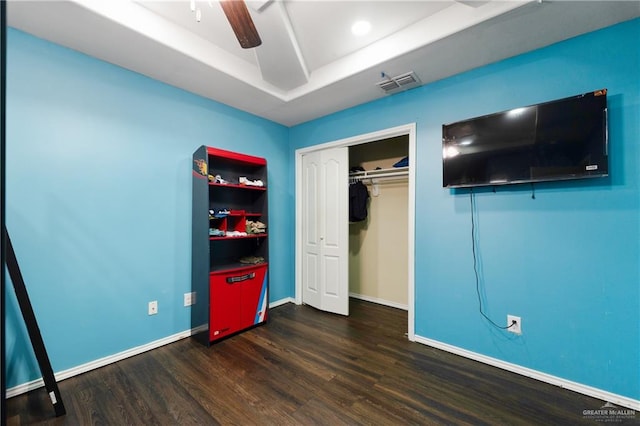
7, 0, 640, 126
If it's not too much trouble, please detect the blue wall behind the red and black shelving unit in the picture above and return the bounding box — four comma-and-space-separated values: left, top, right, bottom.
6, 29, 294, 388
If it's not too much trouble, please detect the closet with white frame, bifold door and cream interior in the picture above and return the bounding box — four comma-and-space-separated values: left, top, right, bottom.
294, 123, 416, 341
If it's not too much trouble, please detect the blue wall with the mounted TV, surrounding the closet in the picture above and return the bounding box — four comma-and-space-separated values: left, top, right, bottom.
290, 19, 640, 399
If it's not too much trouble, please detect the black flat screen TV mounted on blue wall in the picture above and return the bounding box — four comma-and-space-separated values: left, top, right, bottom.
442, 89, 609, 188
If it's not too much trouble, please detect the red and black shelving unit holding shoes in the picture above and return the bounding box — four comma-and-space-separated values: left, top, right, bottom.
191, 146, 269, 345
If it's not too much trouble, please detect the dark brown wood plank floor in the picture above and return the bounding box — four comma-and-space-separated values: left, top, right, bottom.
7, 300, 632, 425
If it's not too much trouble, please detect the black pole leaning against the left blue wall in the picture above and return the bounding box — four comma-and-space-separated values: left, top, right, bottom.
2, 227, 66, 417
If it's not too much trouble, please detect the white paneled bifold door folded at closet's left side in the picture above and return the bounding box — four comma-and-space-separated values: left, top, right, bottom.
302, 147, 349, 315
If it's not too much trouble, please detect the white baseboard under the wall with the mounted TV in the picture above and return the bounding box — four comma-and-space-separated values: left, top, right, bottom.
415, 335, 640, 411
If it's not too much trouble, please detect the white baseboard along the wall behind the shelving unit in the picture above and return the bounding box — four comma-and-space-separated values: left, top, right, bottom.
6, 297, 294, 398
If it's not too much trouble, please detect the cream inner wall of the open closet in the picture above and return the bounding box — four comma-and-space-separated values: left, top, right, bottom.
349, 136, 409, 309
